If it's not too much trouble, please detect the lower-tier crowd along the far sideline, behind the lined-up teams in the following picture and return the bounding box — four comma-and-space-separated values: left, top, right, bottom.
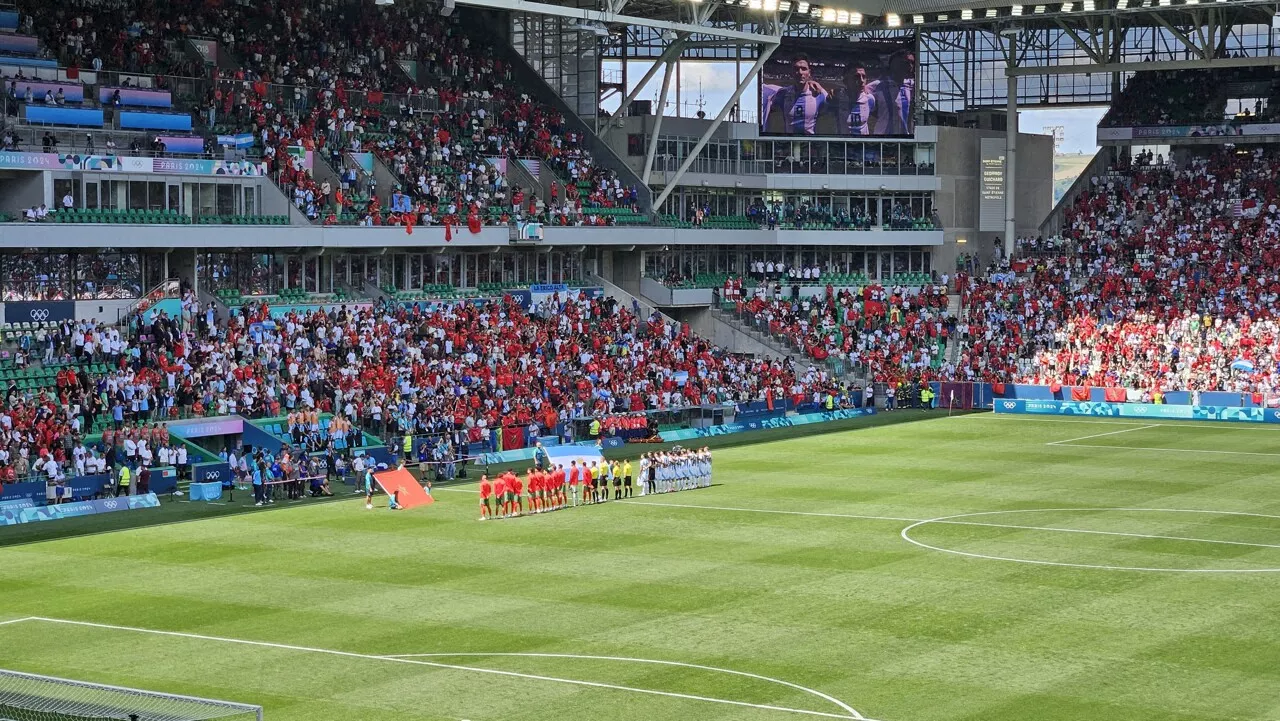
0, 280, 829, 480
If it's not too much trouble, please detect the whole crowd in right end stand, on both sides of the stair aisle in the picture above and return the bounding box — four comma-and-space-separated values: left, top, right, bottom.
737, 149, 1280, 398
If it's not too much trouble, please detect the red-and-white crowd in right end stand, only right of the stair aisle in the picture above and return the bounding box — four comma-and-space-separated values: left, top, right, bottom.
961, 149, 1280, 396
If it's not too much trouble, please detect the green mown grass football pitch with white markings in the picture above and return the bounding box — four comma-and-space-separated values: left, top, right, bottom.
0, 415, 1280, 721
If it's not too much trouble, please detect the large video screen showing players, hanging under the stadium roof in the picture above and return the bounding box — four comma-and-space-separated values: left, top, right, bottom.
760, 38, 915, 137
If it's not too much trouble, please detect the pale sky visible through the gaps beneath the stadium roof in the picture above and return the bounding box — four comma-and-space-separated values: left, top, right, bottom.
604, 60, 1106, 154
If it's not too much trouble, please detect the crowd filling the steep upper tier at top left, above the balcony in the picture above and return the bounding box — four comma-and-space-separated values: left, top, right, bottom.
20, 0, 624, 227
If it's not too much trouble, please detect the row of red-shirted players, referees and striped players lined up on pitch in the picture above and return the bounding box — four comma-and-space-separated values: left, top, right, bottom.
480, 448, 712, 521
